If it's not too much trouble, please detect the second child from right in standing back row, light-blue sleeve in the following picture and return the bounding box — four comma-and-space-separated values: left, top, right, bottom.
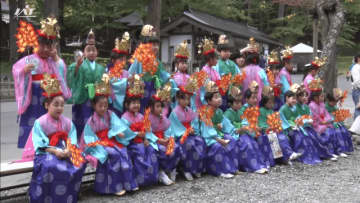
275, 46, 293, 103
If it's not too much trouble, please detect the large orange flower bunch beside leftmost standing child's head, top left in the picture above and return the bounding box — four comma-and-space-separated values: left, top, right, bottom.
15, 20, 39, 53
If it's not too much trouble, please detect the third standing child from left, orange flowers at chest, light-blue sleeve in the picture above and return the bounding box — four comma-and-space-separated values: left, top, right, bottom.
108, 32, 130, 117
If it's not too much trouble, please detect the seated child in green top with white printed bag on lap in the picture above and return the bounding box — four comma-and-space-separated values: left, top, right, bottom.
257, 91, 301, 166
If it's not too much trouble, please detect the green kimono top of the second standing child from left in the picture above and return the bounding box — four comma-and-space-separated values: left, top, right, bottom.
67, 59, 105, 104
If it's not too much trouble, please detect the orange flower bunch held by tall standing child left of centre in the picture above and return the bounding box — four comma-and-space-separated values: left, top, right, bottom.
130, 43, 159, 75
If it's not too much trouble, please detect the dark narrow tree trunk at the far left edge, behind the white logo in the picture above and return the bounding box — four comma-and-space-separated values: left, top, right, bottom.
9, 0, 25, 63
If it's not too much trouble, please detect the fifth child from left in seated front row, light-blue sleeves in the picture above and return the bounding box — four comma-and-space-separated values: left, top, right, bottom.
169, 78, 206, 180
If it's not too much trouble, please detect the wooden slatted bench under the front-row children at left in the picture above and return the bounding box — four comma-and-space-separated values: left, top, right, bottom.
0, 161, 95, 200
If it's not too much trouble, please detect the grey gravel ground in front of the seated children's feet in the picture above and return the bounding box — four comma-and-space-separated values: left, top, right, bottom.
6, 146, 360, 203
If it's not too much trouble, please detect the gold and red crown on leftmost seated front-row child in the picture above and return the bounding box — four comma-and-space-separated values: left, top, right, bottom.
40, 73, 62, 98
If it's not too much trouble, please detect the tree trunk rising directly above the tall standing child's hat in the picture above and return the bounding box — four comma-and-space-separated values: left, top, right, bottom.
146, 0, 161, 37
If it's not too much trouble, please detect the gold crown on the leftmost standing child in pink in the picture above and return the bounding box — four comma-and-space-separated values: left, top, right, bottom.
38, 17, 60, 39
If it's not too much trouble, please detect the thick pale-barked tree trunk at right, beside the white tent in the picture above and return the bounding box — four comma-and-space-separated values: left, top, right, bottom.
316, 0, 345, 92
